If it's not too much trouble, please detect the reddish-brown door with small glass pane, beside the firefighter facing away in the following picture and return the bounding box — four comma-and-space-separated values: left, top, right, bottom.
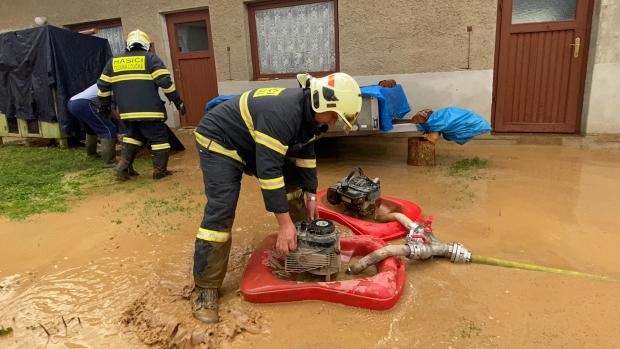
166, 10, 217, 127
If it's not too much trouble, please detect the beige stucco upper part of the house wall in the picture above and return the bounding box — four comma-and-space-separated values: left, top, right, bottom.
0, 0, 497, 80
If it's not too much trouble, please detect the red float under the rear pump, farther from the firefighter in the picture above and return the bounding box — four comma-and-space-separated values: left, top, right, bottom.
317, 189, 430, 241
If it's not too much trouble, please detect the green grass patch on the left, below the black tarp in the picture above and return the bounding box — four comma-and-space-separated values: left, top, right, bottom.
0, 145, 110, 220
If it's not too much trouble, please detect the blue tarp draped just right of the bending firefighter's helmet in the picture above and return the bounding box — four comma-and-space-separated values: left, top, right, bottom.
361, 84, 411, 131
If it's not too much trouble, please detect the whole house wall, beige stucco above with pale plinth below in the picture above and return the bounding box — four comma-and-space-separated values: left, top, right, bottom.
0, 0, 620, 133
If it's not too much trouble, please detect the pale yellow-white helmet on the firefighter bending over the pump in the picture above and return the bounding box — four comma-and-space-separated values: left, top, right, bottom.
297, 73, 362, 130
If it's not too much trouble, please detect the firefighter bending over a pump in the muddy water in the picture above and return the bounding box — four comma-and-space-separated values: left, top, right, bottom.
191, 73, 362, 323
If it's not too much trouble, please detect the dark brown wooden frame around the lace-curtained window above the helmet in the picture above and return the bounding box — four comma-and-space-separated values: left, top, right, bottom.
247, 0, 340, 80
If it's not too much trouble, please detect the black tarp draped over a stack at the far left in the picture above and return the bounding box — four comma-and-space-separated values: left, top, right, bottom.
0, 26, 112, 136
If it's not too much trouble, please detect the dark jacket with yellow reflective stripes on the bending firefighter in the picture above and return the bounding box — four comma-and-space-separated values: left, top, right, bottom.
196, 88, 319, 213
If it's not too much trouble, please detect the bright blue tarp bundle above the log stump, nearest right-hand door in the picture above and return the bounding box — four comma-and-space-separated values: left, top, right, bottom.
416, 107, 491, 145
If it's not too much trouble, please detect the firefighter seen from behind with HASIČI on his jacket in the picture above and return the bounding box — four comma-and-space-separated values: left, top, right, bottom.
97, 30, 185, 180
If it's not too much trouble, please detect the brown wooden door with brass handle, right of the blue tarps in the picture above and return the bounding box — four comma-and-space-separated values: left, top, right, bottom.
493, 0, 593, 133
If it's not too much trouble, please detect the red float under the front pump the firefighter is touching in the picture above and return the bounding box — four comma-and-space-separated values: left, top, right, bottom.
241, 235, 405, 310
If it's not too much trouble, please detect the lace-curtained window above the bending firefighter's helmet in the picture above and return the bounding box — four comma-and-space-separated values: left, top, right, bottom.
248, 0, 338, 79
